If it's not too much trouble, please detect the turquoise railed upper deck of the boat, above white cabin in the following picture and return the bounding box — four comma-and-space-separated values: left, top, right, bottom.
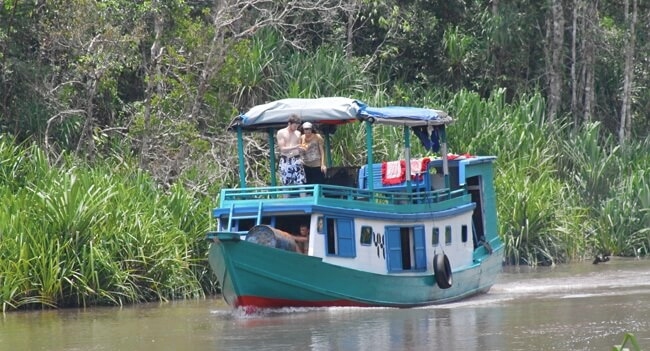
214, 157, 494, 216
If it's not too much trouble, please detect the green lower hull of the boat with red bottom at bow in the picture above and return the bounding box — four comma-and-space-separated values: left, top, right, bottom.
209, 233, 503, 308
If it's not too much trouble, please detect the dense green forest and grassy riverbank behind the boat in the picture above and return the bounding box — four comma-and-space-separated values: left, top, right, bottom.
0, 0, 650, 311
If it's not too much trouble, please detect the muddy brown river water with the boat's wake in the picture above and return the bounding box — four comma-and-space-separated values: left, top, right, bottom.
0, 258, 650, 351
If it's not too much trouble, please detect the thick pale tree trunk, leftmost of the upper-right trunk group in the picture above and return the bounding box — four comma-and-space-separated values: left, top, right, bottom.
547, 0, 564, 123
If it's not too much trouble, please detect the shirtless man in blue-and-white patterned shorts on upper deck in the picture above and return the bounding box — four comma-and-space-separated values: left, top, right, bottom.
277, 115, 306, 185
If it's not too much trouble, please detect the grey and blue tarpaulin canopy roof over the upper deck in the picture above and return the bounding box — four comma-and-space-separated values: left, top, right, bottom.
228, 97, 453, 131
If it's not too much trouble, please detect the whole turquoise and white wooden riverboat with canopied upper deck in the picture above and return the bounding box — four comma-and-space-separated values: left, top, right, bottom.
207, 97, 503, 308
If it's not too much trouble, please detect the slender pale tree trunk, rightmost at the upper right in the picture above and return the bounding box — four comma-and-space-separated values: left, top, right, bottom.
618, 0, 637, 145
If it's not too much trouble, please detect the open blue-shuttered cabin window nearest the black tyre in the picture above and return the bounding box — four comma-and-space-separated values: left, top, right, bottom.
385, 225, 427, 272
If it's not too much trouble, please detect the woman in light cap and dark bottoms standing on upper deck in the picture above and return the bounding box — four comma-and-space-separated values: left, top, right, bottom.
300, 122, 327, 184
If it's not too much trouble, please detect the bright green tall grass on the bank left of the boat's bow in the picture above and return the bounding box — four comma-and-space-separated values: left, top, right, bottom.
0, 140, 215, 310
